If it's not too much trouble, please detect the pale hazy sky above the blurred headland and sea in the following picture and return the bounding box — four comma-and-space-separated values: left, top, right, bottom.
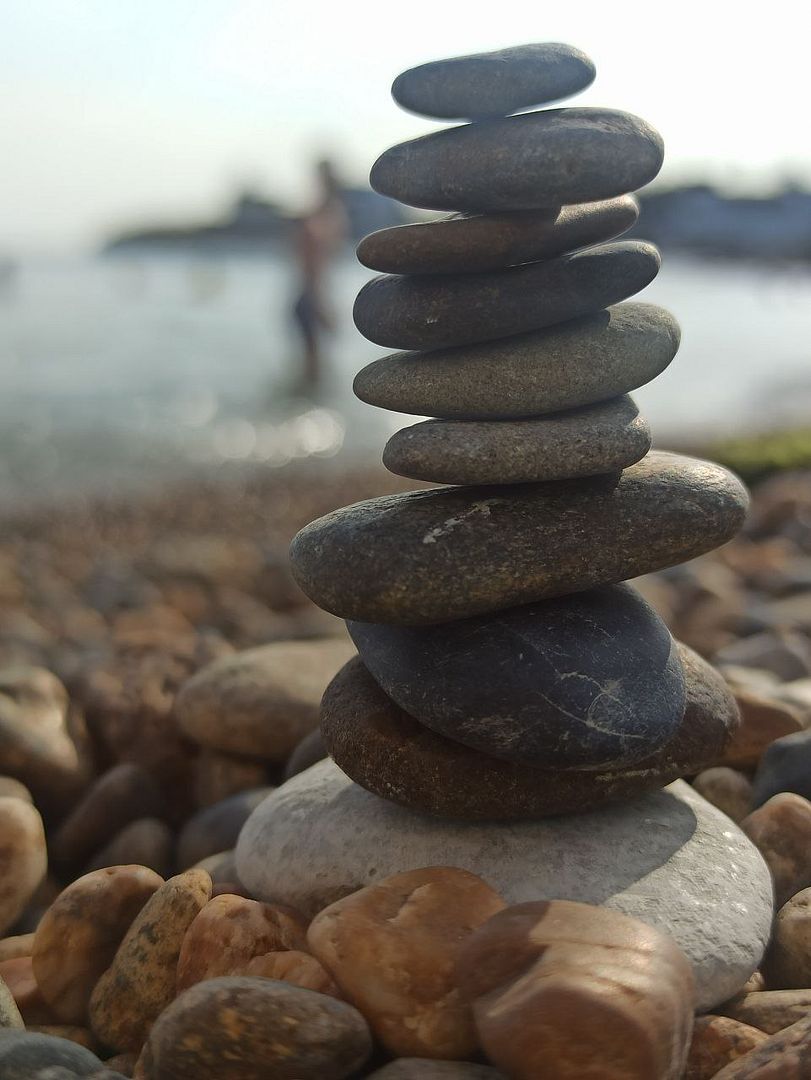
0, 0, 811, 256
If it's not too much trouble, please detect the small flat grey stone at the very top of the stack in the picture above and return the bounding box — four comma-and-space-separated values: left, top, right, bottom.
391, 42, 596, 120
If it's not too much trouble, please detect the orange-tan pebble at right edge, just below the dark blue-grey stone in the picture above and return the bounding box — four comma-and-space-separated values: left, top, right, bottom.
741, 792, 811, 907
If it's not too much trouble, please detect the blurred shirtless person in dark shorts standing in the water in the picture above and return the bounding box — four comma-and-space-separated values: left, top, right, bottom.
293, 160, 349, 393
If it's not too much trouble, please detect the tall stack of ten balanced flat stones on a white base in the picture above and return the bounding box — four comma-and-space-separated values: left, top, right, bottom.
238, 44, 770, 1004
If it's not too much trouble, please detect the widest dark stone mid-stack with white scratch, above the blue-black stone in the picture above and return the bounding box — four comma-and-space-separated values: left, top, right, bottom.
290, 451, 748, 625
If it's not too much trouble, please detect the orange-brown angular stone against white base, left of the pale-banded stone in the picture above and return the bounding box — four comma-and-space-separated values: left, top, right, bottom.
307, 866, 504, 1058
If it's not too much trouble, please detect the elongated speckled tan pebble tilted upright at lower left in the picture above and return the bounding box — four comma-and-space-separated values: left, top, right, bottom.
90, 870, 212, 1051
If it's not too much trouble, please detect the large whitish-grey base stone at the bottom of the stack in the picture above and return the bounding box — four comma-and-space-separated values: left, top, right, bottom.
236, 761, 772, 1009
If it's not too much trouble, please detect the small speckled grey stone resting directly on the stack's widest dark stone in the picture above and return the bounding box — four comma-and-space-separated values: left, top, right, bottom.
383, 395, 650, 484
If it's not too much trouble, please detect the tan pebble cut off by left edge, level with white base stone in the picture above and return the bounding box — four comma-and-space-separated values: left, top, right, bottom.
0, 795, 48, 934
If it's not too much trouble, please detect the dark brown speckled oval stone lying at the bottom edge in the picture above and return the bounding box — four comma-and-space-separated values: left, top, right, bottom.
136, 978, 371, 1080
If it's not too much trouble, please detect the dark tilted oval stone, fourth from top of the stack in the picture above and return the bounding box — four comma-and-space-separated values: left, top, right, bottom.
353, 240, 661, 349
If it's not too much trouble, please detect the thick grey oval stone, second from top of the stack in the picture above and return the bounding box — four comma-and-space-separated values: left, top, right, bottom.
369, 109, 664, 212
